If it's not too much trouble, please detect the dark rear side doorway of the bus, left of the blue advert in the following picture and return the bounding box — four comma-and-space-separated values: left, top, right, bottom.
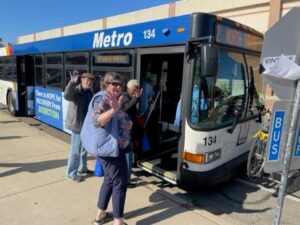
17, 56, 35, 116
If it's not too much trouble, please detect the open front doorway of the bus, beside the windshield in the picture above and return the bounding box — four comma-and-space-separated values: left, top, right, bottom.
134, 47, 184, 183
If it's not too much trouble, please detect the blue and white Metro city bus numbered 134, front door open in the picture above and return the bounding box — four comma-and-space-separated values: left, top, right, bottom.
0, 13, 263, 187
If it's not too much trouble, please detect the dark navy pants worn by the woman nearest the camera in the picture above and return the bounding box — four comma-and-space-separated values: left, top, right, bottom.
98, 150, 127, 218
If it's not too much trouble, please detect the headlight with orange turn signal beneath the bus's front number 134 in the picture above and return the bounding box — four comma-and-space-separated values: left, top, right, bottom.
183, 149, 221, 164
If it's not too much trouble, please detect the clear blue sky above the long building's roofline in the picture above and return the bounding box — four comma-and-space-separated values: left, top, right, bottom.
0, 0, 178, 43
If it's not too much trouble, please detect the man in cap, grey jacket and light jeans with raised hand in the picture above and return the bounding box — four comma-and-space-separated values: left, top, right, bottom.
64, 70, 95, 182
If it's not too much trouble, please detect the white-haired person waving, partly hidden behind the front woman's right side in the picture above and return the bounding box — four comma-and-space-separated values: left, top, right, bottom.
122, 80, 143, 188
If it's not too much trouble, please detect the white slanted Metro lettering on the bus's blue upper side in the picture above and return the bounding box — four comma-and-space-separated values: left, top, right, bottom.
93, 30, 133, 48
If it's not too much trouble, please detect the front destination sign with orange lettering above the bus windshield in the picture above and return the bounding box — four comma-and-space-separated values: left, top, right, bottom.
216, 23, 263, 51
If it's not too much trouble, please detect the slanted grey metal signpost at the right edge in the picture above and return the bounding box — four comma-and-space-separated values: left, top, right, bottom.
273, 80, 300, 225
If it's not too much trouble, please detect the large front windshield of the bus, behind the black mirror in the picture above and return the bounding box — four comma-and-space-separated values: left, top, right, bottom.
189, 50, 259, 130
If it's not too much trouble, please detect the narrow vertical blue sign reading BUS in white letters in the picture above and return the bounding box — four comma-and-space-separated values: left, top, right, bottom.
268, 110, 285, 161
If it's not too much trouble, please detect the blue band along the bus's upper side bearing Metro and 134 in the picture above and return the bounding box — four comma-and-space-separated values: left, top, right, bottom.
13, 15, 191, 55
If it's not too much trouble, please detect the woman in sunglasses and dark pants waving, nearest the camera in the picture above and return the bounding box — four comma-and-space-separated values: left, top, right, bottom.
88, 72, 132, 225
